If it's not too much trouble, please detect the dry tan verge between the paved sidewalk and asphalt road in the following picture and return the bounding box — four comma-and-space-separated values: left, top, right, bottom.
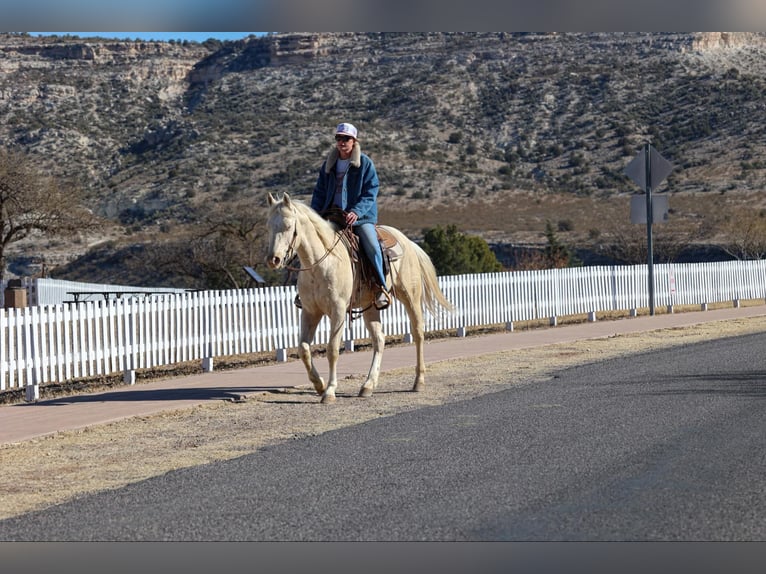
0, 317, 766, 519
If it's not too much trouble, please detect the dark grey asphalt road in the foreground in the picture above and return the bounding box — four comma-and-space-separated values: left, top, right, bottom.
0, 333, 766, 541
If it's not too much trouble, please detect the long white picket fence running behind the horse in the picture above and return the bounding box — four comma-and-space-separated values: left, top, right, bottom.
0, 261, 766, 400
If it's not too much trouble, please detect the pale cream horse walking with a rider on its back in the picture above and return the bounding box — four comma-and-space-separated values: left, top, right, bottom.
266, 193, 453, 404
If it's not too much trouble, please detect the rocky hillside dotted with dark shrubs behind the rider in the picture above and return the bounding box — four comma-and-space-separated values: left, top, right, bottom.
0, 33, 766, 284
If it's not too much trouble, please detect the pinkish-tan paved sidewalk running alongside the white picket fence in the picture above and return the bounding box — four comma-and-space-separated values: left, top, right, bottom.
0, 305, 766, 444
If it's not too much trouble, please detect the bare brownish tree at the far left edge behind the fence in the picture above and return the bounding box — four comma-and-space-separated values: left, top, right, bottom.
0, 147, 97, 277
